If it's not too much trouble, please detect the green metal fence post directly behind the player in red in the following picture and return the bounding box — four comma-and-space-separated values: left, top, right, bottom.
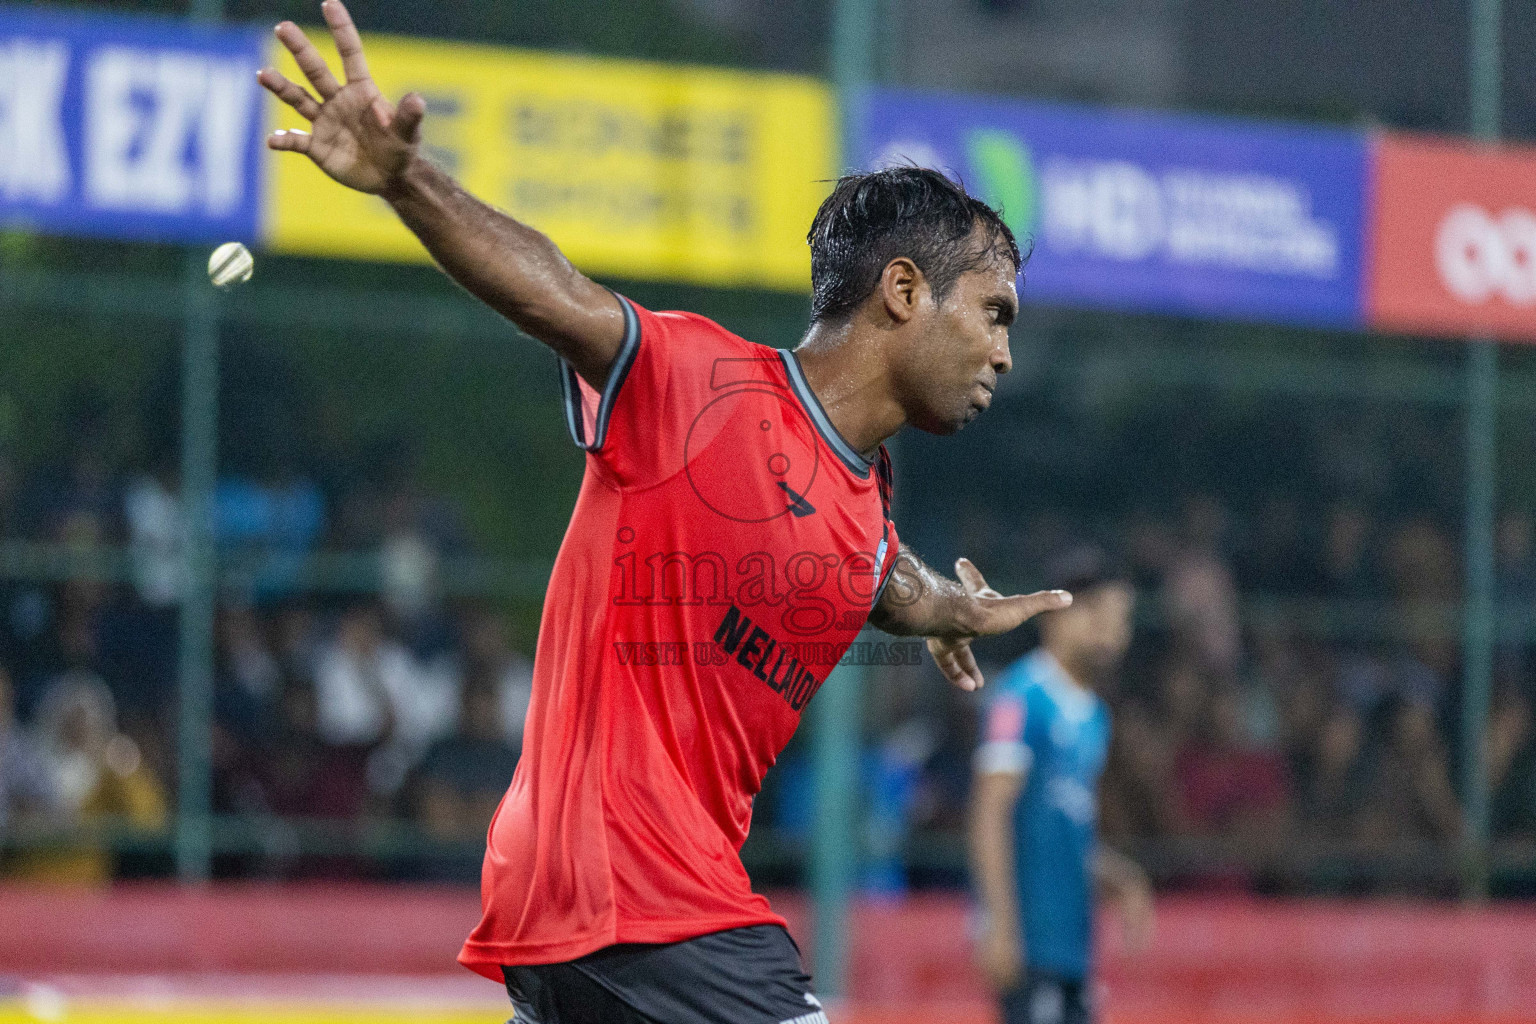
811, 0, 879, 998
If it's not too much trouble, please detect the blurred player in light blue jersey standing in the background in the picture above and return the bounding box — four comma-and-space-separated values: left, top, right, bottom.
971, 548, 1152, 1024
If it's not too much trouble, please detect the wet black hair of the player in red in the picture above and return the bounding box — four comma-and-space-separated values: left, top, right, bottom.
805, 167, 1025, 321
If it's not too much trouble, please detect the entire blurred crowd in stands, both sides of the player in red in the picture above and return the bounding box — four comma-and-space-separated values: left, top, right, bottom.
0, 388, 1536, 892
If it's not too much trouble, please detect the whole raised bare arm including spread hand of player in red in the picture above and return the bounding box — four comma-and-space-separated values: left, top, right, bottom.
257, 0, 624, 390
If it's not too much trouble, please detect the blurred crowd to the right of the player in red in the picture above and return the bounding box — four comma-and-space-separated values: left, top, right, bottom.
804, 494, 1536, 895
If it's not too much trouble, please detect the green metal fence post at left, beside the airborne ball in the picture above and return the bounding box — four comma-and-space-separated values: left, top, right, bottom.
175, 0, 224, 883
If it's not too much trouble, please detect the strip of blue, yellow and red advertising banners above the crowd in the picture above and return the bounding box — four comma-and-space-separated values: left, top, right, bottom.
9, 6, 1536, 341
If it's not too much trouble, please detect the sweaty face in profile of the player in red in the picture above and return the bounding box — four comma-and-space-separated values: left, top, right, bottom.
902, 239, 1018, 434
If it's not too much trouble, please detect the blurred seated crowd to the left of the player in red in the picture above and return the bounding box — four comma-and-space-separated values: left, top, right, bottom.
0, 401, 531, 881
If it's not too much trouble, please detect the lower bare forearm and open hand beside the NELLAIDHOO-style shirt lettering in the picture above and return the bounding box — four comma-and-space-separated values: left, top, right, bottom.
869, 543, 1072, 689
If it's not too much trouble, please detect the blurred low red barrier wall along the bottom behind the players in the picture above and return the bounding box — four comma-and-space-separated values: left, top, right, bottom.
0, 886, 1536, 1024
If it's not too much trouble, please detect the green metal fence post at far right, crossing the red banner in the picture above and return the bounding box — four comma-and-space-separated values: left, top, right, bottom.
1461, 0, 1502, 900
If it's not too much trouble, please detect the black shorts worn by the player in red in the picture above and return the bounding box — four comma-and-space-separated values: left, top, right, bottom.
501, 924, 828, 1024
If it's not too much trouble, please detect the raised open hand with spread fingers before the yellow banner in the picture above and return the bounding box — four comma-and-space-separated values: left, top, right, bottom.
257, 0, 427, 195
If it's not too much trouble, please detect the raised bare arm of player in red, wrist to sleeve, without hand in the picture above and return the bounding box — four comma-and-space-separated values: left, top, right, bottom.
384, 158, 624, 387
